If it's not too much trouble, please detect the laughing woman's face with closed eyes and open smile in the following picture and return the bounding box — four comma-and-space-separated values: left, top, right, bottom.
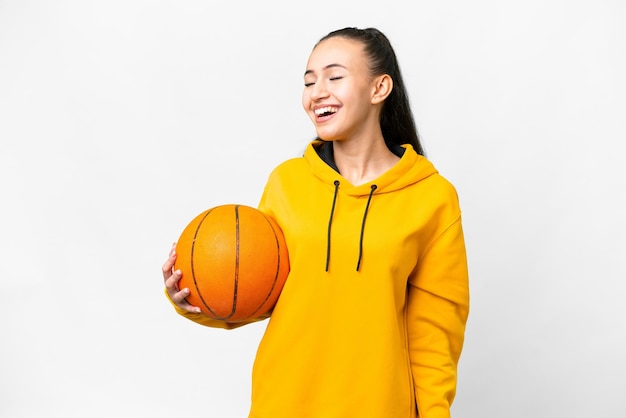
302, 37, 379, 141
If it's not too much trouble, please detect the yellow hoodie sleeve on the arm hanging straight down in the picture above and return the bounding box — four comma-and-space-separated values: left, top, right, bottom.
407, 216, 469, 418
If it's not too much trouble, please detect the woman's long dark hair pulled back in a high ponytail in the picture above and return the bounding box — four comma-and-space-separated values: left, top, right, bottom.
315, 27, 424, 155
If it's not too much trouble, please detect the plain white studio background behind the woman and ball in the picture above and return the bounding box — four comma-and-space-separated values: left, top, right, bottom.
0, 0, 626, 418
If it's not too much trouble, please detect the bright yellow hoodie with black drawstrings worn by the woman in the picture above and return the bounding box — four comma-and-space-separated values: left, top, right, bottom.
171, 141, 469, 418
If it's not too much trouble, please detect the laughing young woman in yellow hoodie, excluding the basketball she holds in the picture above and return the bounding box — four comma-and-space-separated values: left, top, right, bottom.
163, 28, 469, 418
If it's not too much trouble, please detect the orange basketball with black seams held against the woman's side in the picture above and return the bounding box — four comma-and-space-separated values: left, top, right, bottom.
174, 204, 289, 322
